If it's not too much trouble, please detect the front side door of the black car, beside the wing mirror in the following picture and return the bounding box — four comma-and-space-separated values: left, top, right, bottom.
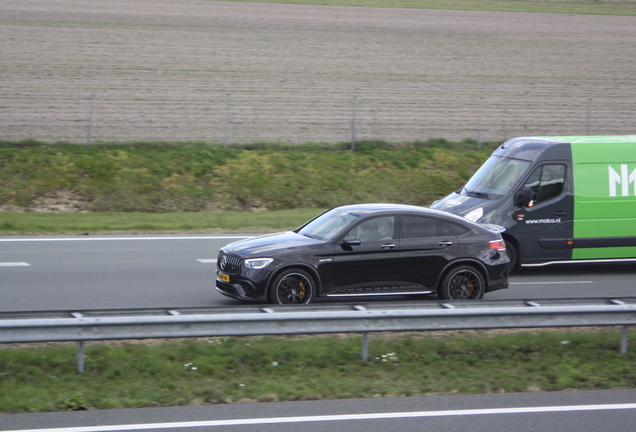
320, 215, 399, 294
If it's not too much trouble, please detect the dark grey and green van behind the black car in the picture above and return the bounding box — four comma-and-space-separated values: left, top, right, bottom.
431, 135, 636, 269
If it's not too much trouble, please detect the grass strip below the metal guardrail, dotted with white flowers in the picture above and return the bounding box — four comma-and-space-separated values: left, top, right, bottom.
0, 330, 636, 413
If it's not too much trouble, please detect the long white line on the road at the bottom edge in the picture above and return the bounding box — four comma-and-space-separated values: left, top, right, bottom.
5, 403, 636, 432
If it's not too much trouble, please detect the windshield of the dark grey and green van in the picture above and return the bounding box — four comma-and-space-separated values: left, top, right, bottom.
463, 156, 530, 198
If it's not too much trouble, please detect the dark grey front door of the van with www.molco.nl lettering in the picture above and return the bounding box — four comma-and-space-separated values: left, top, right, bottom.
513, 163, 574, 263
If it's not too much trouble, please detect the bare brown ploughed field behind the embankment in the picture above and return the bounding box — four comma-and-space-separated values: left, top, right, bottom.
0, 0, 636, 143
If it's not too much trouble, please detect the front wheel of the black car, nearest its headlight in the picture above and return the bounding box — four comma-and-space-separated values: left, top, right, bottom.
268, 269, 316, 304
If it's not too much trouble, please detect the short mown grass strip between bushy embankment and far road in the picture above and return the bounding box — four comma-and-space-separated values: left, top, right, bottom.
0, 209, 321, 235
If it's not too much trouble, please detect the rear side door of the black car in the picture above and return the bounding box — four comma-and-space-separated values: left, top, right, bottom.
397, 215, 459, 290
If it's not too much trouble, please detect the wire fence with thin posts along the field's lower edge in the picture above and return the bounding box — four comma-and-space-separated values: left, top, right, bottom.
0, 93, 636, 148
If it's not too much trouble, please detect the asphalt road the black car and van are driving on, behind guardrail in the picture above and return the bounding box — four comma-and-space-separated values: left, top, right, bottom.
0, 235, 636, 311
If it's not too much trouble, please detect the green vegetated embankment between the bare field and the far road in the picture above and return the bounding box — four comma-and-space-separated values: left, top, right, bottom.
0, 139, 500, 234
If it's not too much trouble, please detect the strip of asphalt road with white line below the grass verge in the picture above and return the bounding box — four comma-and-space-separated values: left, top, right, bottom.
0, 390, 636, 432
